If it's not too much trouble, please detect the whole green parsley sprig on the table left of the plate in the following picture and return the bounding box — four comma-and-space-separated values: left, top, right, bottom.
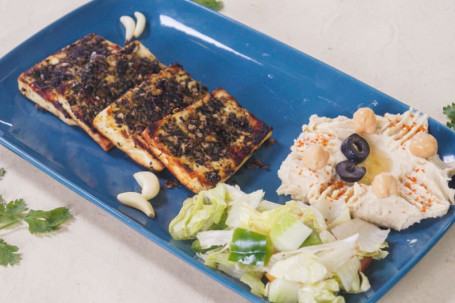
0, 168, 71, 266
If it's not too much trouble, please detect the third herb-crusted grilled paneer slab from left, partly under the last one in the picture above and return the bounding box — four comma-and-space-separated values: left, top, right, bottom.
93, 65, 212, 171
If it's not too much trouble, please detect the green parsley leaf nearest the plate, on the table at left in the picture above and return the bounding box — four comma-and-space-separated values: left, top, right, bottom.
24, 207, 71, 234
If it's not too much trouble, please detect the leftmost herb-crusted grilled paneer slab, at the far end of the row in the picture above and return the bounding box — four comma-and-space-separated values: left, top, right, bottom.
18, 34, 121, 125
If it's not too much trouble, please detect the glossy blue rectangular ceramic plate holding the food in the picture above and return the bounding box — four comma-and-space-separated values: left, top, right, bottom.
0, 0, 455, 302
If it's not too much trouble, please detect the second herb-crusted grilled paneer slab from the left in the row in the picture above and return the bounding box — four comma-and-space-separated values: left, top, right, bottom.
57, 41, 165, 150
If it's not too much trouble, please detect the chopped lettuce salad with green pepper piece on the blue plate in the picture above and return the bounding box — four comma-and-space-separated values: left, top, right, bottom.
169, 183, 389, 302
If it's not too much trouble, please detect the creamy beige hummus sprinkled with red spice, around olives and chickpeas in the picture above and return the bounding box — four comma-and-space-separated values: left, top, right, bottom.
277, 109, 455, 230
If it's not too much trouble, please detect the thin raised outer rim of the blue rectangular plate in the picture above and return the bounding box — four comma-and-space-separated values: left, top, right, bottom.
0, 0, 455, 302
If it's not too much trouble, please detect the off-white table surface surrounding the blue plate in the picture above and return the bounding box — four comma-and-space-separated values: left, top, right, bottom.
0, 0, 455, 303
